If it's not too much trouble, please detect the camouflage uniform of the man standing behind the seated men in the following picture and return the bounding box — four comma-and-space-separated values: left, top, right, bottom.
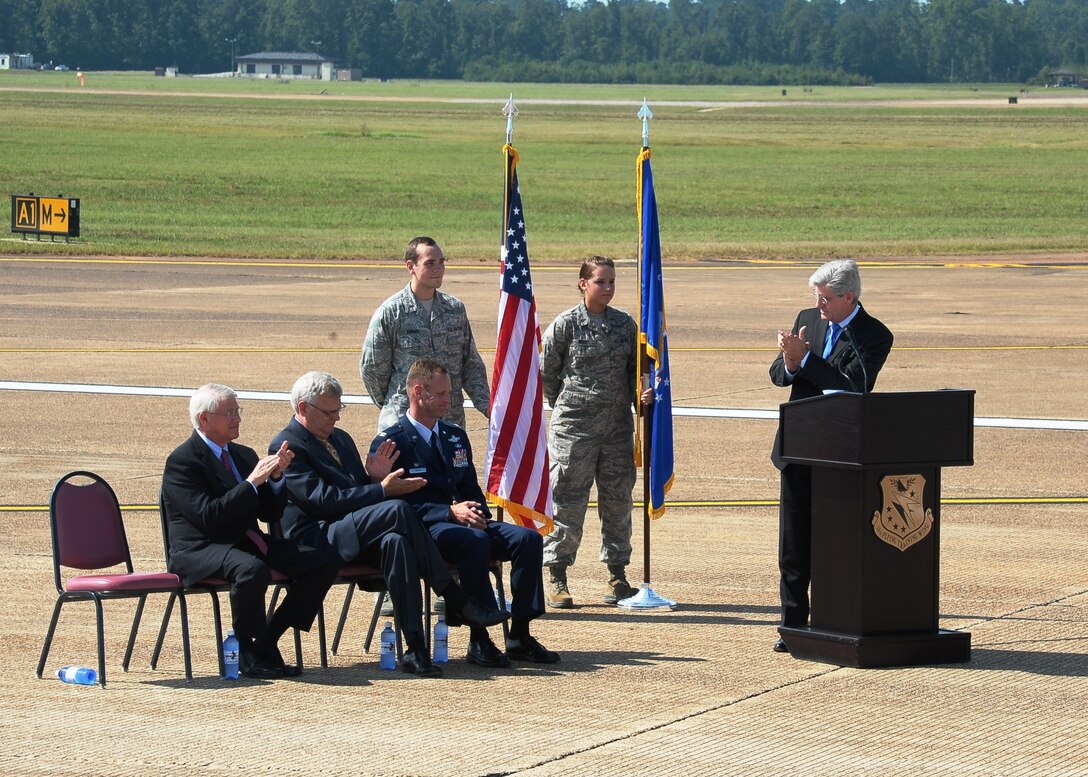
359, 285, 491, 431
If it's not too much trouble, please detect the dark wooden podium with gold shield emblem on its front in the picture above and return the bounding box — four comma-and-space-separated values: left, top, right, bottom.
779, 390, 975, 667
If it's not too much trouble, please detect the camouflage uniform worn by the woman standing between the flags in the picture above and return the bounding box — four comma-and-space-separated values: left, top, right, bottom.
541, 304, 639, 567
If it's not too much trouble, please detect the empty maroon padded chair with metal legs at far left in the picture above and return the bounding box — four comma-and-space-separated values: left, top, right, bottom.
37, 471, 193, 688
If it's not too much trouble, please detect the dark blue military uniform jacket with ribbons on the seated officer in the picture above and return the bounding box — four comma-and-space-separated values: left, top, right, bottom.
370, 416, 491, 526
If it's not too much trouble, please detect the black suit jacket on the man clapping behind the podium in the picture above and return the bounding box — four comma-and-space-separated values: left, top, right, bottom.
770, 300, 893, 469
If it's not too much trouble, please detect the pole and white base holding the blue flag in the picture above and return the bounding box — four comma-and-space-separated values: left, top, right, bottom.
617, 98, 677, 612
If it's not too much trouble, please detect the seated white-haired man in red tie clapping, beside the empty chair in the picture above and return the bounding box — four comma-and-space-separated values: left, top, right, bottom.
162, 383, 339, 678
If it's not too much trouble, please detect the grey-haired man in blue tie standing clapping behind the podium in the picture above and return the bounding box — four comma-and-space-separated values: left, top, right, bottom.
770, 259, 892, 653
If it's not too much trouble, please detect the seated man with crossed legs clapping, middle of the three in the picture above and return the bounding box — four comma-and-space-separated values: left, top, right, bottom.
269, 372, 509, 677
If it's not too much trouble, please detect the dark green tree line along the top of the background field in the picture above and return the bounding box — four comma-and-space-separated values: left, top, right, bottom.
6, 0, 1088, 84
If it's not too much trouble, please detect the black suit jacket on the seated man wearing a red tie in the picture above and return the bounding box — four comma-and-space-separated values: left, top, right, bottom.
162, 431, 287, 585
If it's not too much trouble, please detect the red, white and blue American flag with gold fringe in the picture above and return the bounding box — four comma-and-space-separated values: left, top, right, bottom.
485, 144, 554, 534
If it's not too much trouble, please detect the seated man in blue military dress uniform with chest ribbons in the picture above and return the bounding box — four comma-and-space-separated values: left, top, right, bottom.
370, 359, 559, 666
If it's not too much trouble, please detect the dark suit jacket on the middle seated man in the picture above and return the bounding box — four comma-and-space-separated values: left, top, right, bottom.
269, 418, 385, 562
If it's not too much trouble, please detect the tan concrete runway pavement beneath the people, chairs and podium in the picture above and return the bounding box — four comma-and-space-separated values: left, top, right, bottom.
0, 252, 1088, 775
